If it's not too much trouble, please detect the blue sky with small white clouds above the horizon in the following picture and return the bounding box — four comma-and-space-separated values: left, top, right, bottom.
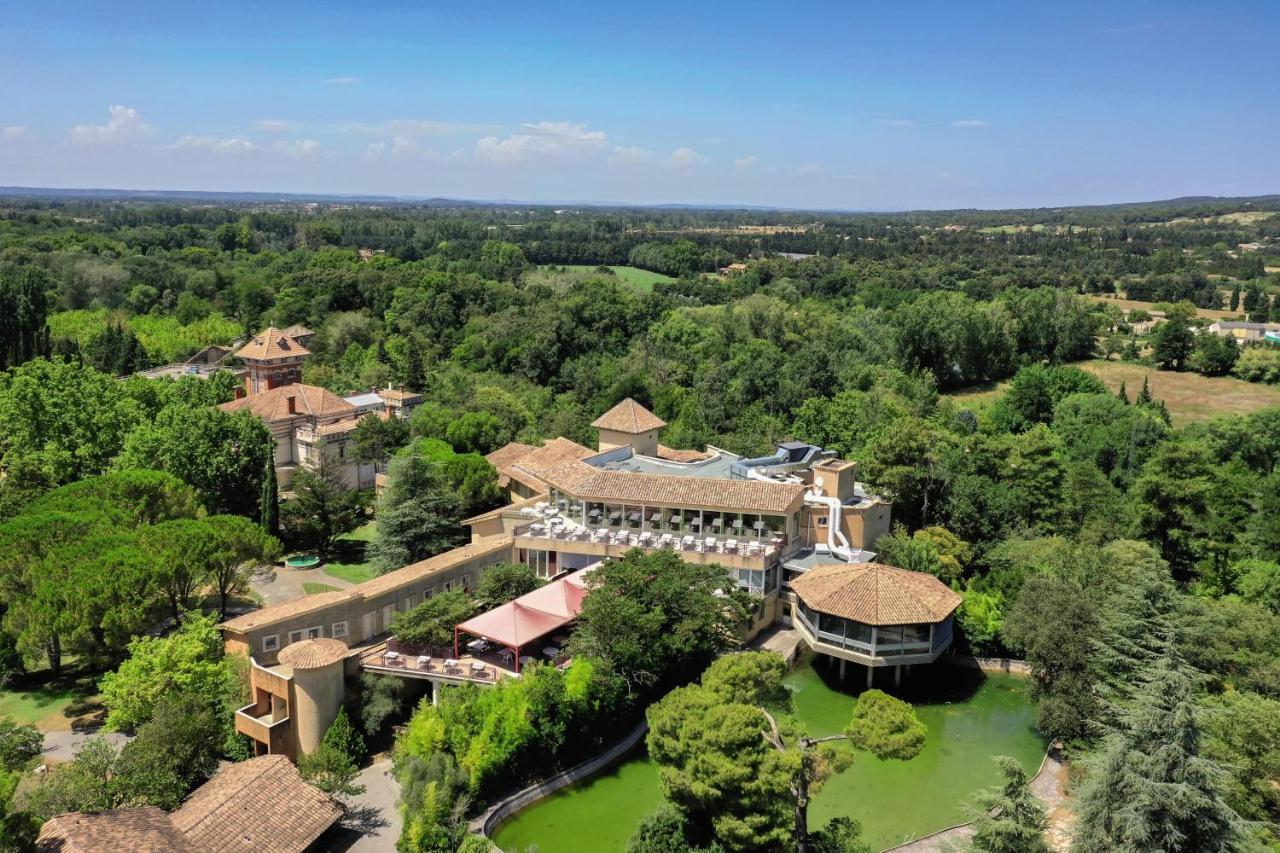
0, 0, 1280, 210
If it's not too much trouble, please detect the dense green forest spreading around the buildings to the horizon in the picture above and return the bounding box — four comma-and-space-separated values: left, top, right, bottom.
0, 196, 1280, 850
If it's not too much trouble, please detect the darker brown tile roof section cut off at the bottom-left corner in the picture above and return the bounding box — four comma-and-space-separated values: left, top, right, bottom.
36, 806, 198, 853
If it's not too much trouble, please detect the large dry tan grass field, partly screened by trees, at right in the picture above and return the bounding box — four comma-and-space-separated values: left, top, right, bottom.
946, 359, 1280, 427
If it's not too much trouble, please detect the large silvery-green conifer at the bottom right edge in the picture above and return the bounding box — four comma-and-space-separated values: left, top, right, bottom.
1073, 643, 1242, 853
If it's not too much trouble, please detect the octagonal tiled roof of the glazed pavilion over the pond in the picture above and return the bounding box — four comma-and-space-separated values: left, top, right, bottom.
791, 562, 961, 625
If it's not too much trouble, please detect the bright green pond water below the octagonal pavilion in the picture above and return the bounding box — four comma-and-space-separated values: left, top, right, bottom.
494, 661, 1047, 853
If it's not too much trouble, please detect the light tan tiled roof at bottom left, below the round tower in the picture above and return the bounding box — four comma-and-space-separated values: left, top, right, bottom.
170, 756, 342, 853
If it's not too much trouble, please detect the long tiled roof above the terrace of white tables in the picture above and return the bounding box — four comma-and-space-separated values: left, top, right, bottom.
527, 460, 804, 514
